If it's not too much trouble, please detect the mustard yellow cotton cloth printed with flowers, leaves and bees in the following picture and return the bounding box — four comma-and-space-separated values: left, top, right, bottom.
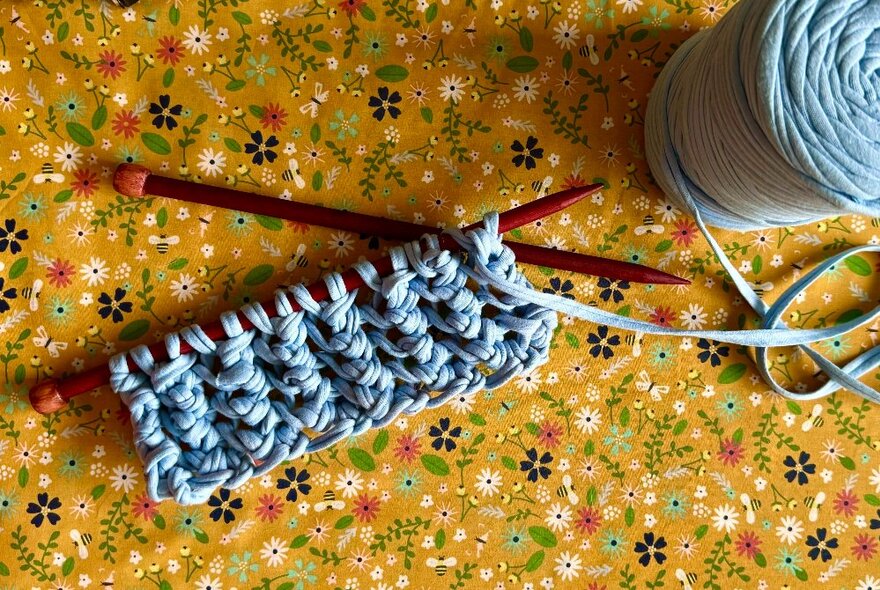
0, 0, 880, 590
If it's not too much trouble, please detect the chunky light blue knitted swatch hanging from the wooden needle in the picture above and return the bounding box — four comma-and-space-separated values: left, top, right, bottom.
110, 214, 557, 504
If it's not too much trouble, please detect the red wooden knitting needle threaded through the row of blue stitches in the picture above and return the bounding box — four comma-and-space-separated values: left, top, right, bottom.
28, 190, 590, 414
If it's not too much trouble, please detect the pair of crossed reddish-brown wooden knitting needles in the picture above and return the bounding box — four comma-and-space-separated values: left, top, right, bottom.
29, 164, 689, 414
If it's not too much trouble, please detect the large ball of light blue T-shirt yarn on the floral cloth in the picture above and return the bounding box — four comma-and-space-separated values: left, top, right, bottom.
645, 0, 880, 230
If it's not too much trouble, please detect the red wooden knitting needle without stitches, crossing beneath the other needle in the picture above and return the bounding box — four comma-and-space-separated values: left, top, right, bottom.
113, 164, 690, 285
